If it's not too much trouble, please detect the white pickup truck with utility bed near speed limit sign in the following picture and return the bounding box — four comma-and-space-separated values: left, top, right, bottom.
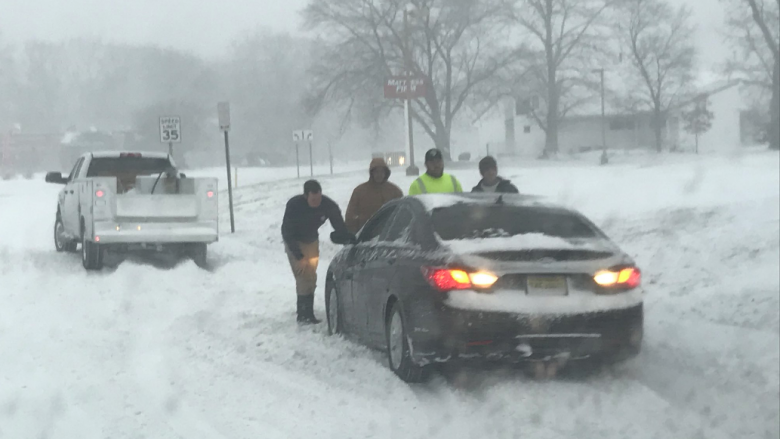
46, 152, 219, 270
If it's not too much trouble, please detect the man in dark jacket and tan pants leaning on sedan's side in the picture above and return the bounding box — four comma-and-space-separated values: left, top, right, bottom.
282, 180, 354, 324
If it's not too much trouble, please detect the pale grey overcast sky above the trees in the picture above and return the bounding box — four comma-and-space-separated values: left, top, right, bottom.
0, 0, 728, 67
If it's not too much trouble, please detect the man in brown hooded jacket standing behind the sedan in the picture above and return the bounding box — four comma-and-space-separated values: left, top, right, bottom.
345, 158, 404, 233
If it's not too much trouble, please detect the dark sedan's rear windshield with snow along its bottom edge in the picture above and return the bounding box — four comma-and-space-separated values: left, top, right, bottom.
432, 203, 598, 241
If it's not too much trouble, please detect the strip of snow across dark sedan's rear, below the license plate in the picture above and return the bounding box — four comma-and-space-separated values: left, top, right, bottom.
445, 289, 644, 315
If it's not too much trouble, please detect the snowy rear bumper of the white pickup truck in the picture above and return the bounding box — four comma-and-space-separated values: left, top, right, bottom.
94, 221, 219, 244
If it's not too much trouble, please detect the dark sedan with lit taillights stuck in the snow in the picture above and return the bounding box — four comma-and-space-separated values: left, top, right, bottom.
325, 194, 643, 382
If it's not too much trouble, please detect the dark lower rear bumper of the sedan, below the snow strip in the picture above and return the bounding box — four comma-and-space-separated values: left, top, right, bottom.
409, 304, 644, 365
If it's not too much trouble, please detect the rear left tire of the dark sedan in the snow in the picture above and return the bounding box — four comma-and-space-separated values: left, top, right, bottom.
385, 302, 431, 383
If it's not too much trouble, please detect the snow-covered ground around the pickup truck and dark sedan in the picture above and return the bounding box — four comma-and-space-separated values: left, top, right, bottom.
0, 150, 780, 439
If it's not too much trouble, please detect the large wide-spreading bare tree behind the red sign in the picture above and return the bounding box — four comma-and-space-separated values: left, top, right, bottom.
303, 0, 523, 160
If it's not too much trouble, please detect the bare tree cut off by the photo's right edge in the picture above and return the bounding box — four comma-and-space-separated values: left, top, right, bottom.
726, 0, 780, 150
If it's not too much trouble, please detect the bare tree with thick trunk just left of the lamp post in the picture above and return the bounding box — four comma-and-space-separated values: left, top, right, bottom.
515, 0, 611, 154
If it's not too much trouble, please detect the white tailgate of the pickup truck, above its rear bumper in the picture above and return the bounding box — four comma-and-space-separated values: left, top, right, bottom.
116, 194, 199, 221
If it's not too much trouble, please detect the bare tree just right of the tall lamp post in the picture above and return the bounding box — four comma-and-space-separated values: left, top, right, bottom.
621, 0, 696, 152
